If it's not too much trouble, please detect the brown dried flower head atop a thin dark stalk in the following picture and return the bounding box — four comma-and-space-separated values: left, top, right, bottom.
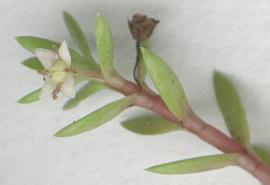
128, 13, 159, 41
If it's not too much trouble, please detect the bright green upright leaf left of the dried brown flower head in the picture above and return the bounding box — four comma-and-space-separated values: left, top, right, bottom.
96, 14, 114, 79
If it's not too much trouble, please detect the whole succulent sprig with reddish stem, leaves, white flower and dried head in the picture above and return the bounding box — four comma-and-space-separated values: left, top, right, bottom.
17, 12, 270, 185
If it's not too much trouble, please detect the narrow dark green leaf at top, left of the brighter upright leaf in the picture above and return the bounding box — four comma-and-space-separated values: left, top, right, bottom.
63, 12, 93, 61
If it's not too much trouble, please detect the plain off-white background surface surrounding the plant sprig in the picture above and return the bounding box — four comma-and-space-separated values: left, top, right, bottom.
0, 0, 270, 185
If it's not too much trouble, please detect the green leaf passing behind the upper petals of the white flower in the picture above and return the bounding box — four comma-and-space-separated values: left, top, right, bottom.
16, 36, 99, 70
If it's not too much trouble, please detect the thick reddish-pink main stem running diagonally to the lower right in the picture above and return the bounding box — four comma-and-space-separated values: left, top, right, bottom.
87, 72, 270, 185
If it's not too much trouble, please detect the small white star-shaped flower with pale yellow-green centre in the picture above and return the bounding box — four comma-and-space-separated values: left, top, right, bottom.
35, 41, 75, 99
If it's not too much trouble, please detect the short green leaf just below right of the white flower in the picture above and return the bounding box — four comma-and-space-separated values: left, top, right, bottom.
63, 81, 106, 110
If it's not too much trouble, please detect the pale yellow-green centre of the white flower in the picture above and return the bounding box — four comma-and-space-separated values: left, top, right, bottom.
48, 60, 68, 84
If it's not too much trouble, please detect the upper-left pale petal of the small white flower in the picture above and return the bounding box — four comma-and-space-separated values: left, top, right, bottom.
35, 48, 57, 68
